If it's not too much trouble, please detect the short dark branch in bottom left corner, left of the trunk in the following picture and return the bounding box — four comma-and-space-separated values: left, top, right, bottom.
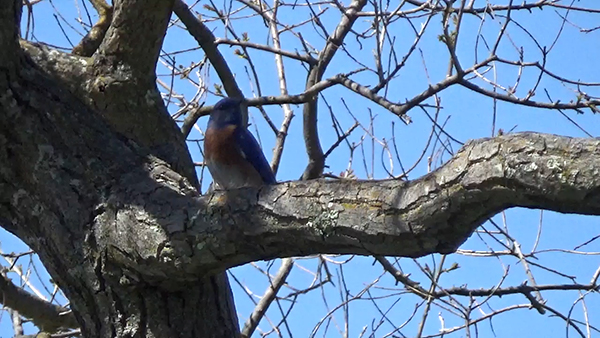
0, 275, 79, 332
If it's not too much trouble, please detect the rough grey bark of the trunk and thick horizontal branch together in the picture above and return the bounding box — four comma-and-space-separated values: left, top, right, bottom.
0, 0, 600, 337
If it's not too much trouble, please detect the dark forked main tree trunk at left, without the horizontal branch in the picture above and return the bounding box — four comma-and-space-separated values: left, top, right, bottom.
0, 1, 239, 337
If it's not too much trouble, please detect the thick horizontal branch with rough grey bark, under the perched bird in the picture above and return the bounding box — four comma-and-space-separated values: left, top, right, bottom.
91, 133, 600, 280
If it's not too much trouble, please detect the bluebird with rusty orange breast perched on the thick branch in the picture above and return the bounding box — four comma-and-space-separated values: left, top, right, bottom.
204, 98, 277, 190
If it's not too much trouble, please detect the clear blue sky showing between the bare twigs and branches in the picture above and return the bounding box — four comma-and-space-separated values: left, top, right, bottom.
0, 0, 600, 337
